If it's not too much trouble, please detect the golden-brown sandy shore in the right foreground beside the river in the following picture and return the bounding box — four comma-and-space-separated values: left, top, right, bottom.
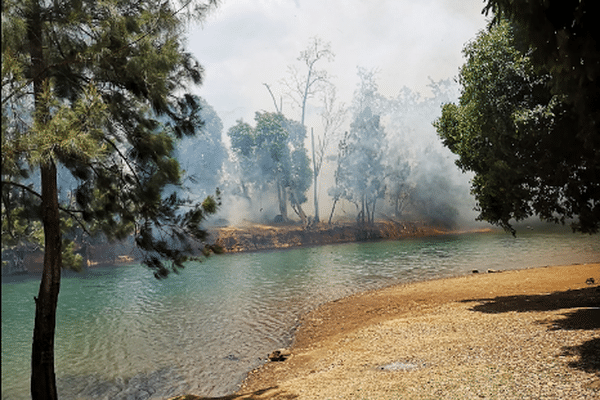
171, 264, 600, 400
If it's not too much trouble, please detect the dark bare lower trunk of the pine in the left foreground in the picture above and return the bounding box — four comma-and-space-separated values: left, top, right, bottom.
31, 161, 62, 400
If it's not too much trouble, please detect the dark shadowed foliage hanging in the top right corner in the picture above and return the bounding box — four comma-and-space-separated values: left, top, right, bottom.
484, 0, 600, 145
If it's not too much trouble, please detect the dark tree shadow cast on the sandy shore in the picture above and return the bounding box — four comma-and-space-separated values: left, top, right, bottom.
462, 286, 600, 373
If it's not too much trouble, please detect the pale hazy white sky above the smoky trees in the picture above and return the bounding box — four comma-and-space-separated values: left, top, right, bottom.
188, 0, 486, 130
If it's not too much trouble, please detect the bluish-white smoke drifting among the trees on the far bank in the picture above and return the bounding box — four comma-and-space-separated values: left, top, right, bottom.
195, 69, 486, 227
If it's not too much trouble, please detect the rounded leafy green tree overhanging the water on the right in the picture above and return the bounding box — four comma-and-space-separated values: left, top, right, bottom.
435, 19, 600, 233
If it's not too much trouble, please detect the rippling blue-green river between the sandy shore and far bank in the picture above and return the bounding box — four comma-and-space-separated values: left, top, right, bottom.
2, 230, 600, 400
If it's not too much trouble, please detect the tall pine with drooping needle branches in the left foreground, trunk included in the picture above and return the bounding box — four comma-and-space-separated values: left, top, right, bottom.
2, 0, 217, 399
